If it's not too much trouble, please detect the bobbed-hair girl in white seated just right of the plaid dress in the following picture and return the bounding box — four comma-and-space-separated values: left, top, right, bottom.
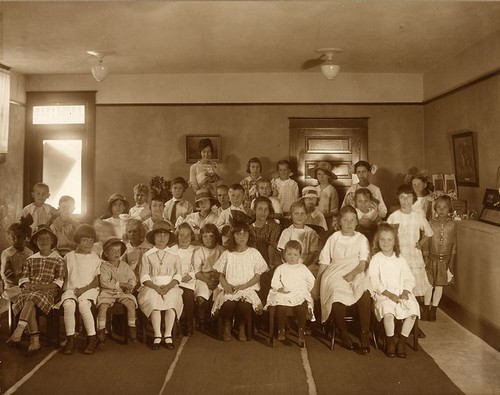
61, 224, 101, 355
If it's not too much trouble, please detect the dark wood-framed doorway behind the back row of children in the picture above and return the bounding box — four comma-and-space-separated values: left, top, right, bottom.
289, 118, 368, 202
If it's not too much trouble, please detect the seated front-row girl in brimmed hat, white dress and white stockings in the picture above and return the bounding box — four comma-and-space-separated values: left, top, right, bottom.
137, 221, 183, 350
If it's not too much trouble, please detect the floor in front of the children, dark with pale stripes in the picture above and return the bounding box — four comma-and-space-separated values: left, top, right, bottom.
0, 311, 500, 395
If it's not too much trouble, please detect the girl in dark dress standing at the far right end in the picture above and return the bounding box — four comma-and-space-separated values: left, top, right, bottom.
422, 195, 457, 321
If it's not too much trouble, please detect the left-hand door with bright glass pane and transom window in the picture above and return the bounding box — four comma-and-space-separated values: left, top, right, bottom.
24, 92, 95, 220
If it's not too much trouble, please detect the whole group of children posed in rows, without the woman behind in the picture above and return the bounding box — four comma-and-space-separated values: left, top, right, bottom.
1, 158, 456, 357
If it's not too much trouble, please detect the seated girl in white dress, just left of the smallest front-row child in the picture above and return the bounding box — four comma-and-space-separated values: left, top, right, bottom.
212, 222, 269, 341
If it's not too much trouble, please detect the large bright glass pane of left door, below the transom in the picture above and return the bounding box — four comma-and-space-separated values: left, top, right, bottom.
43, 140, 82, 214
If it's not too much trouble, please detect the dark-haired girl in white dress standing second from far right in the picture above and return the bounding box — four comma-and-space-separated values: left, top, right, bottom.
387, 184, 434, 297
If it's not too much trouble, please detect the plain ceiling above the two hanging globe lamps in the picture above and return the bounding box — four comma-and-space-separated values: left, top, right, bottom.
0, 0, 500, 74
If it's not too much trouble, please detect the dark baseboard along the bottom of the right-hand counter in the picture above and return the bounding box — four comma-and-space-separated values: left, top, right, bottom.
439, 295, 500, 351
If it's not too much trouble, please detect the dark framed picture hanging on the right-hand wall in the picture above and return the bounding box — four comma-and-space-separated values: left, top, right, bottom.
452, 132, 479, 187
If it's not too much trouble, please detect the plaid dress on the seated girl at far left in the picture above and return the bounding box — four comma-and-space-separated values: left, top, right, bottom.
13, 251, 64, 314
